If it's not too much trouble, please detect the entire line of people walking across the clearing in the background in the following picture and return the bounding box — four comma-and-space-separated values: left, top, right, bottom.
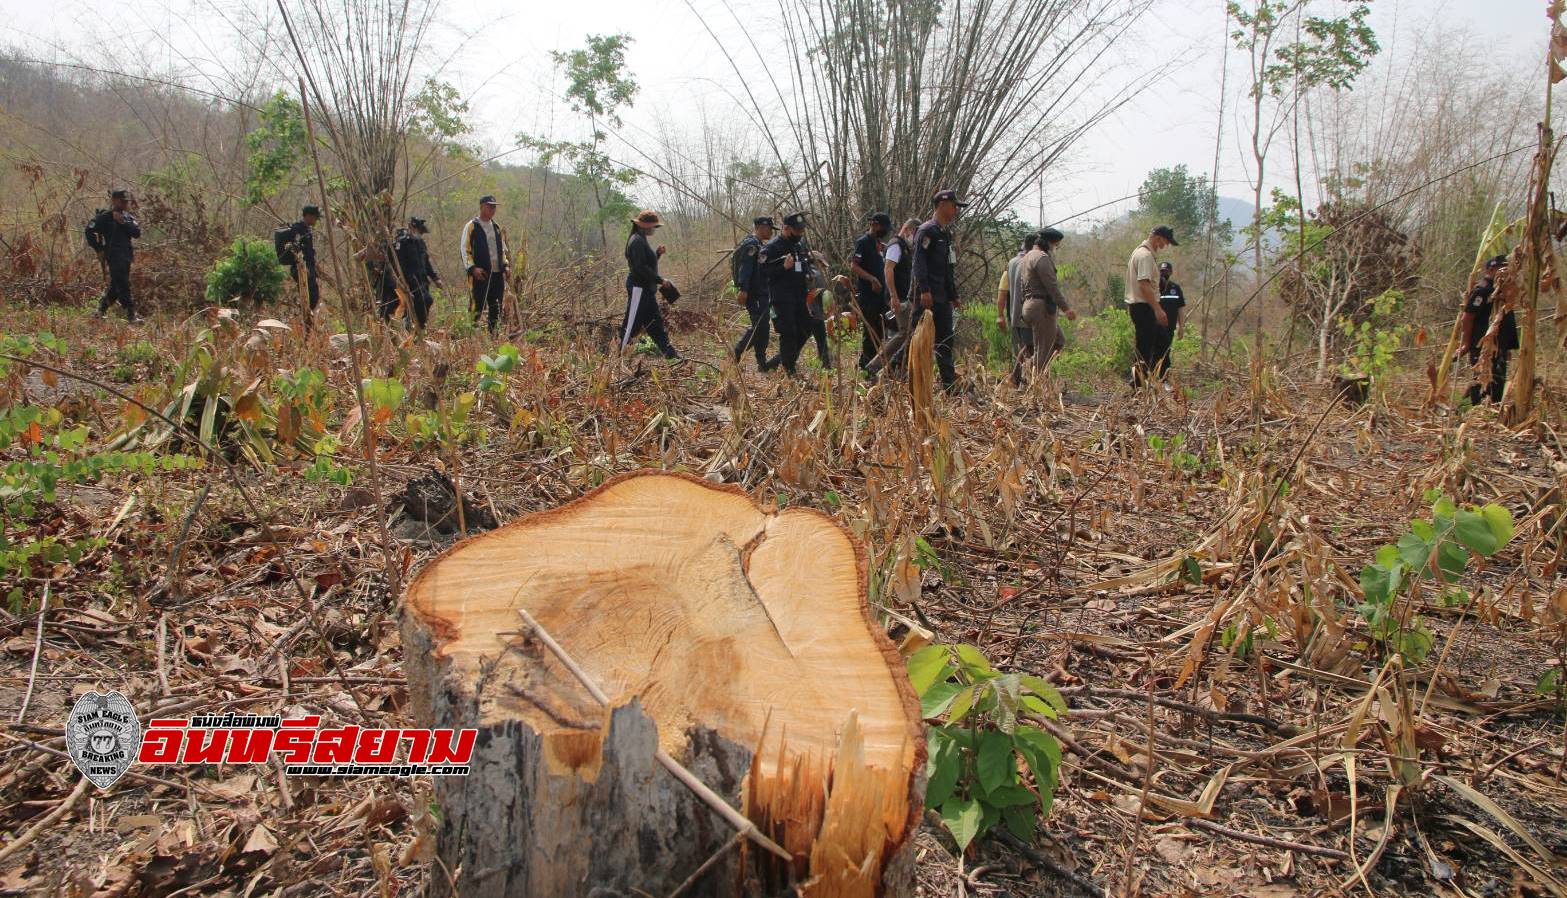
76, 188, 1518, 404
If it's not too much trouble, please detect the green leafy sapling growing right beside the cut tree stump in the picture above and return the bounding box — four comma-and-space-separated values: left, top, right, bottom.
909, 644, 1066, 849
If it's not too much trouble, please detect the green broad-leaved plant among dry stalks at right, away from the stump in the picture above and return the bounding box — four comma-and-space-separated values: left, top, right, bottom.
1355, 495, 1512, 664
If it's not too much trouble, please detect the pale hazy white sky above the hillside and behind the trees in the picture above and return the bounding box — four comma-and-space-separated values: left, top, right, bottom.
0, 0, 1547, 224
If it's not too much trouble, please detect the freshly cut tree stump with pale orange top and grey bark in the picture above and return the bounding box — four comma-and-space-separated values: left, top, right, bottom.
403, 472, 925, 898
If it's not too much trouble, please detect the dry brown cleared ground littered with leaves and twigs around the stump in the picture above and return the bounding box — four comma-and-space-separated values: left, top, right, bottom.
0, 307, 1567, 896
